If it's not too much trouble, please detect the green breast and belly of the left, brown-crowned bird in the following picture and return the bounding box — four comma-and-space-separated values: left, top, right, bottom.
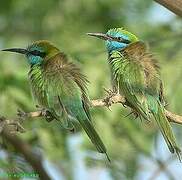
29, 65, 73, 128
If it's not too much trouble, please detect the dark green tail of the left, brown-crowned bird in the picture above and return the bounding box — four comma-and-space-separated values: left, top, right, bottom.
78, 118, 111, 162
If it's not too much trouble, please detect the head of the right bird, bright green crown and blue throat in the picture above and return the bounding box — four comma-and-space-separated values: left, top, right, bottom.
87, 28, 139, 52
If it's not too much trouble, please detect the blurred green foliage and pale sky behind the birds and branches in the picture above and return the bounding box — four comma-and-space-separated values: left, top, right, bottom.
0, 0, 182, 180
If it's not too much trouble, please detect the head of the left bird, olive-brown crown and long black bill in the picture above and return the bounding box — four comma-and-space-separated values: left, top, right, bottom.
2, 40, 59, 65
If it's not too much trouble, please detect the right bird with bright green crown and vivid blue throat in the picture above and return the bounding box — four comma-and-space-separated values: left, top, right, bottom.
87, 28, 181, 159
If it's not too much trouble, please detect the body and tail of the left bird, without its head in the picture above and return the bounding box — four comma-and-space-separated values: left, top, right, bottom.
30, 54, 109, 159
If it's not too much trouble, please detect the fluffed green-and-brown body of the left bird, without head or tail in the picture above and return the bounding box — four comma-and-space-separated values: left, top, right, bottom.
29, 53, 91, 125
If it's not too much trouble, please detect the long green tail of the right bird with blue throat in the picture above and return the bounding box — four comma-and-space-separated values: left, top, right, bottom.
151, 101, 181, 161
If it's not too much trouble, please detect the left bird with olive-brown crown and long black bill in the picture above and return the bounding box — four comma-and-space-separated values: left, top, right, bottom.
3, 40, 110, 161
